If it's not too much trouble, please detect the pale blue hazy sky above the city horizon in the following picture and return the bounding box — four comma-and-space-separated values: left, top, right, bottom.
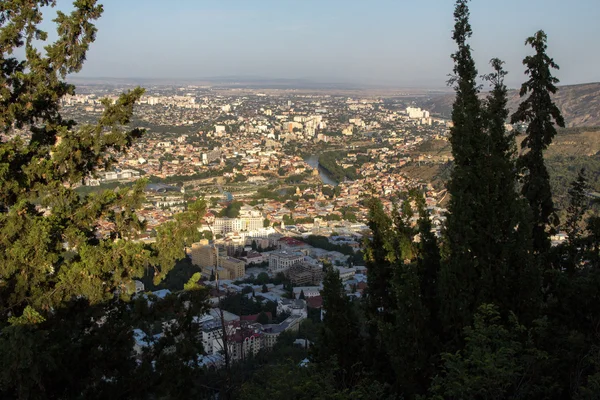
38, 0, 600, 88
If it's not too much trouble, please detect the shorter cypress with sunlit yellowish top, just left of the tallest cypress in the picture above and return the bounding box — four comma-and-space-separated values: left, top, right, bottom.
379, 190, 440, 398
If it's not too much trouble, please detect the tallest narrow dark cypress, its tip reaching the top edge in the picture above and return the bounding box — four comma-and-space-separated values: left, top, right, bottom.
440, 0, 492, 337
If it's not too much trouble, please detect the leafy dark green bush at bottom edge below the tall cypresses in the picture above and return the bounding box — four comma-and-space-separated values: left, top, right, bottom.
431, 304, 552, 399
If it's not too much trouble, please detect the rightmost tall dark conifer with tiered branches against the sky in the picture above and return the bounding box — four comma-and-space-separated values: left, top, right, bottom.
511, 31, 565, 255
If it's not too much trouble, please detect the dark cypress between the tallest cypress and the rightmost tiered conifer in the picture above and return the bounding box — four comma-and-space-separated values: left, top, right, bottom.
477, 59, 539, 317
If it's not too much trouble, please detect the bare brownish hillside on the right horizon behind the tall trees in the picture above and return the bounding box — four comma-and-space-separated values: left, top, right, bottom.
418, 82, 600, 127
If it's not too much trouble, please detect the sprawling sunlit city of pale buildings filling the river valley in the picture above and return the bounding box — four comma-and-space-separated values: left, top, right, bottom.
51, 85, 458, 366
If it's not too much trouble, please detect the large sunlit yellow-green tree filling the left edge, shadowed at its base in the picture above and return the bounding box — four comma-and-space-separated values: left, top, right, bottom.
0, 0, 206, 398
